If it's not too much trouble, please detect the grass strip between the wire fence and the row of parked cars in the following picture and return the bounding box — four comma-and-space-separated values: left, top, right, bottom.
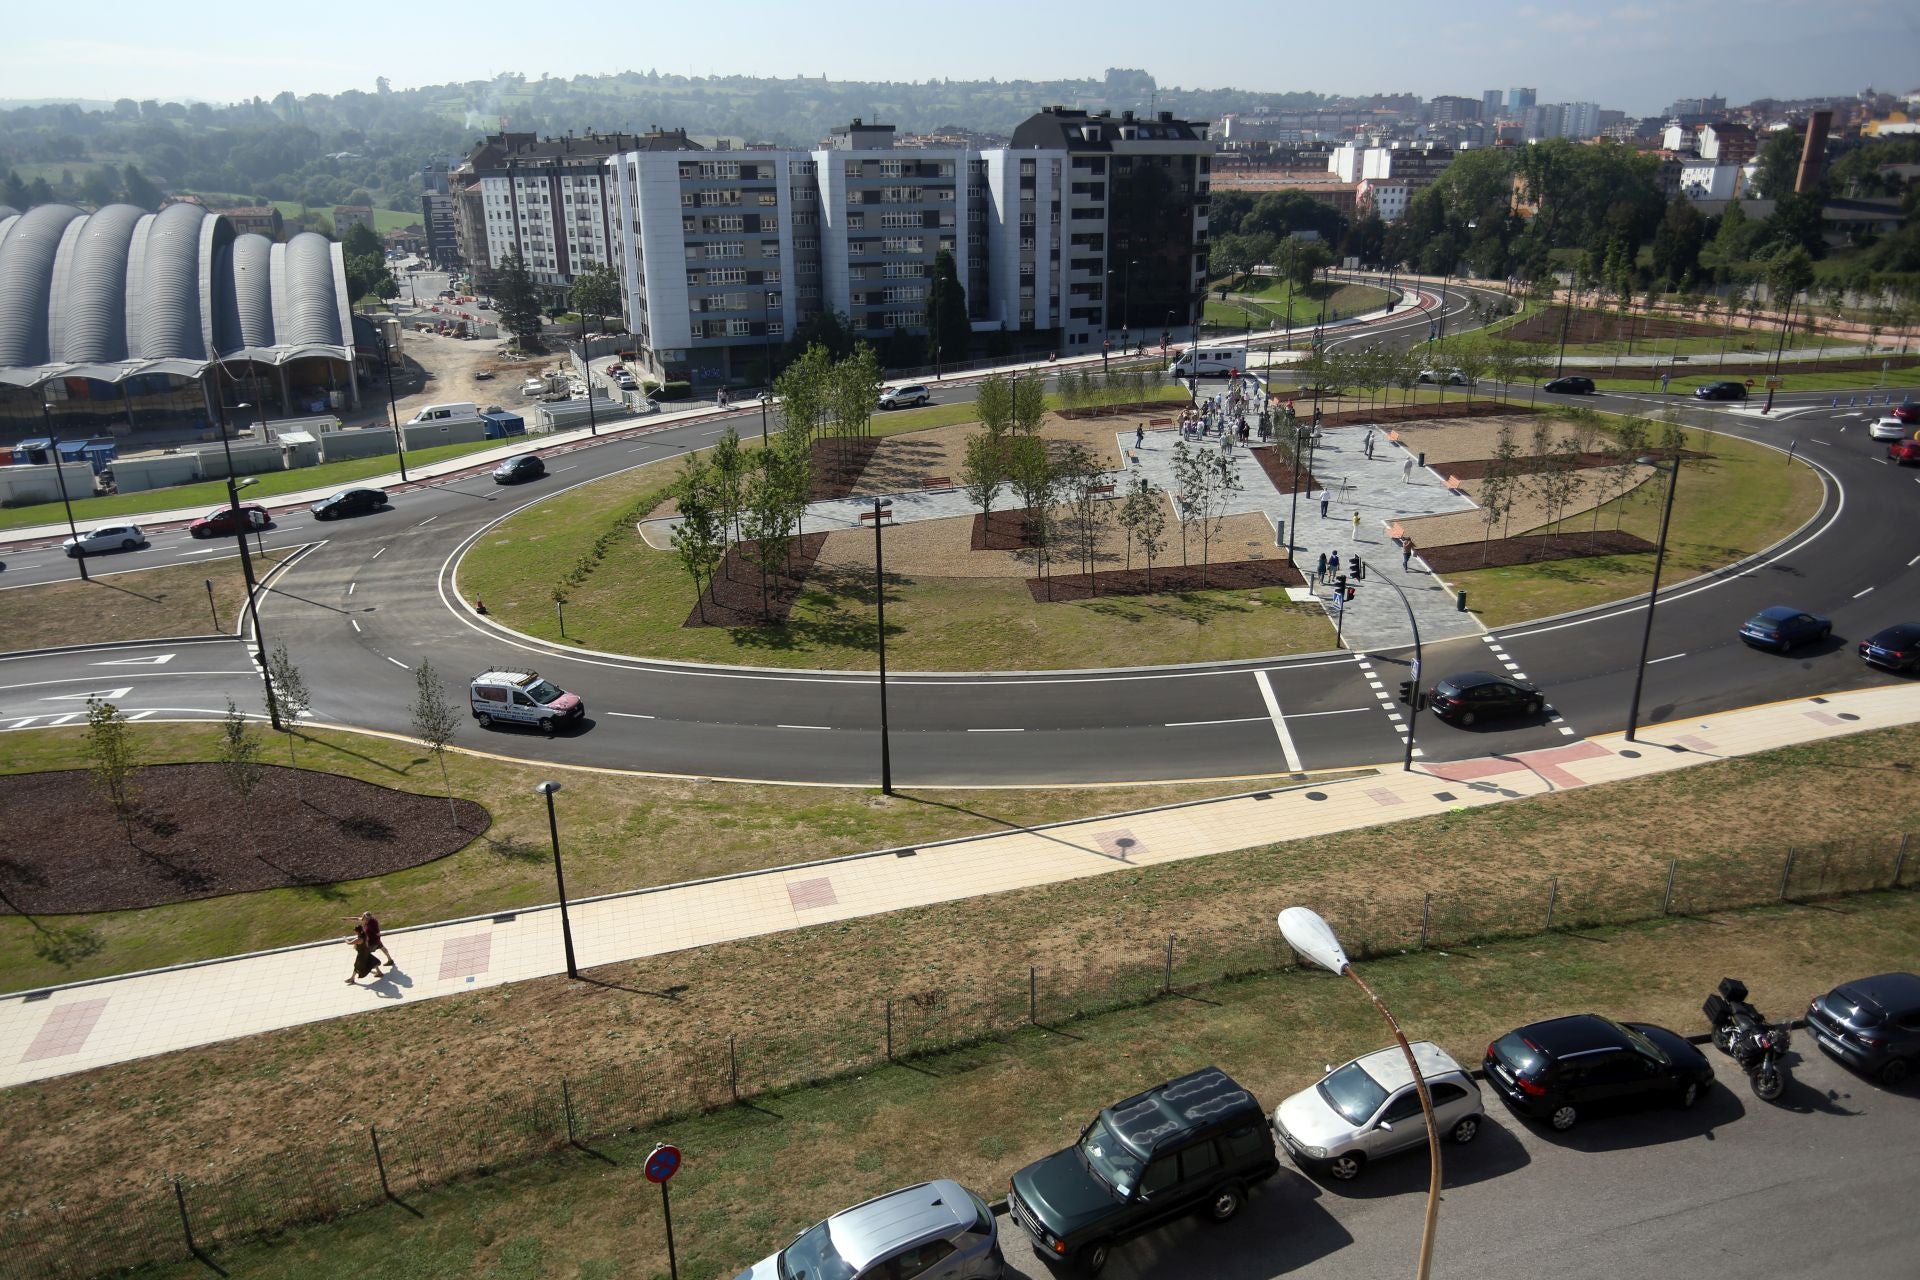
40, 892, 1920, 1280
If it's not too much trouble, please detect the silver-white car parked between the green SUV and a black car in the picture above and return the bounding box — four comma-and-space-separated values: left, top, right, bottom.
1273, 1040, 1482, 1182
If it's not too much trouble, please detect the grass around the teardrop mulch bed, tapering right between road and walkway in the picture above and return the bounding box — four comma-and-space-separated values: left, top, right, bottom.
0, 729, 1320, 990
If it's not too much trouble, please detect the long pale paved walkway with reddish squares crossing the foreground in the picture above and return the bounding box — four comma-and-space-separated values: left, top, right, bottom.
0, 683, 1920, 1086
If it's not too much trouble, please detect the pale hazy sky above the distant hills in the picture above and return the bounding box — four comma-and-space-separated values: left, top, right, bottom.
15, 0, 1920, 115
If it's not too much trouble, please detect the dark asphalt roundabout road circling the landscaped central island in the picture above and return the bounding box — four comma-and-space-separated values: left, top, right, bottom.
0, 290, 1920, 785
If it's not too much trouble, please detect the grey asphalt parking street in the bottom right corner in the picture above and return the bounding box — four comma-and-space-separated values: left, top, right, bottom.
1000, 1032, 1920, 1280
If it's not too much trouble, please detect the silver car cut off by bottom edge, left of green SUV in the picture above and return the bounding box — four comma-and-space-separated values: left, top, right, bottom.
735, 1178, 1008, 1280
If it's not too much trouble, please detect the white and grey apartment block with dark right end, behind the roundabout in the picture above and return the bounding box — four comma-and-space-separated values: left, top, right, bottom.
607, 107, 1215, 384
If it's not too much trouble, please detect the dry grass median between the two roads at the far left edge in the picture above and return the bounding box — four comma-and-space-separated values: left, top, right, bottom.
0, 537, 286, 652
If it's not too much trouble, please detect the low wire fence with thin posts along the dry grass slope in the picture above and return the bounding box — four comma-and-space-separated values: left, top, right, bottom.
0, 835, 1916, 1280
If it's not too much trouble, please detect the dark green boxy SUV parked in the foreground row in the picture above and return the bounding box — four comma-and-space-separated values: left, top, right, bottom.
1006, 1067, 1281, 1274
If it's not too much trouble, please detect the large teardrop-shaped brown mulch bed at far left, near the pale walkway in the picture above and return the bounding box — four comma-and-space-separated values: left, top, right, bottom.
0, 764, 493, 915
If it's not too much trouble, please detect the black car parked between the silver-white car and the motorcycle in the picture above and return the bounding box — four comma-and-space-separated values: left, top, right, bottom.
1484, 1013, 1713, 1130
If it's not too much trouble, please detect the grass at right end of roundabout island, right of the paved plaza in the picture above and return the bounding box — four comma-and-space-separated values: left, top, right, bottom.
1448, 420, 1822, 626
